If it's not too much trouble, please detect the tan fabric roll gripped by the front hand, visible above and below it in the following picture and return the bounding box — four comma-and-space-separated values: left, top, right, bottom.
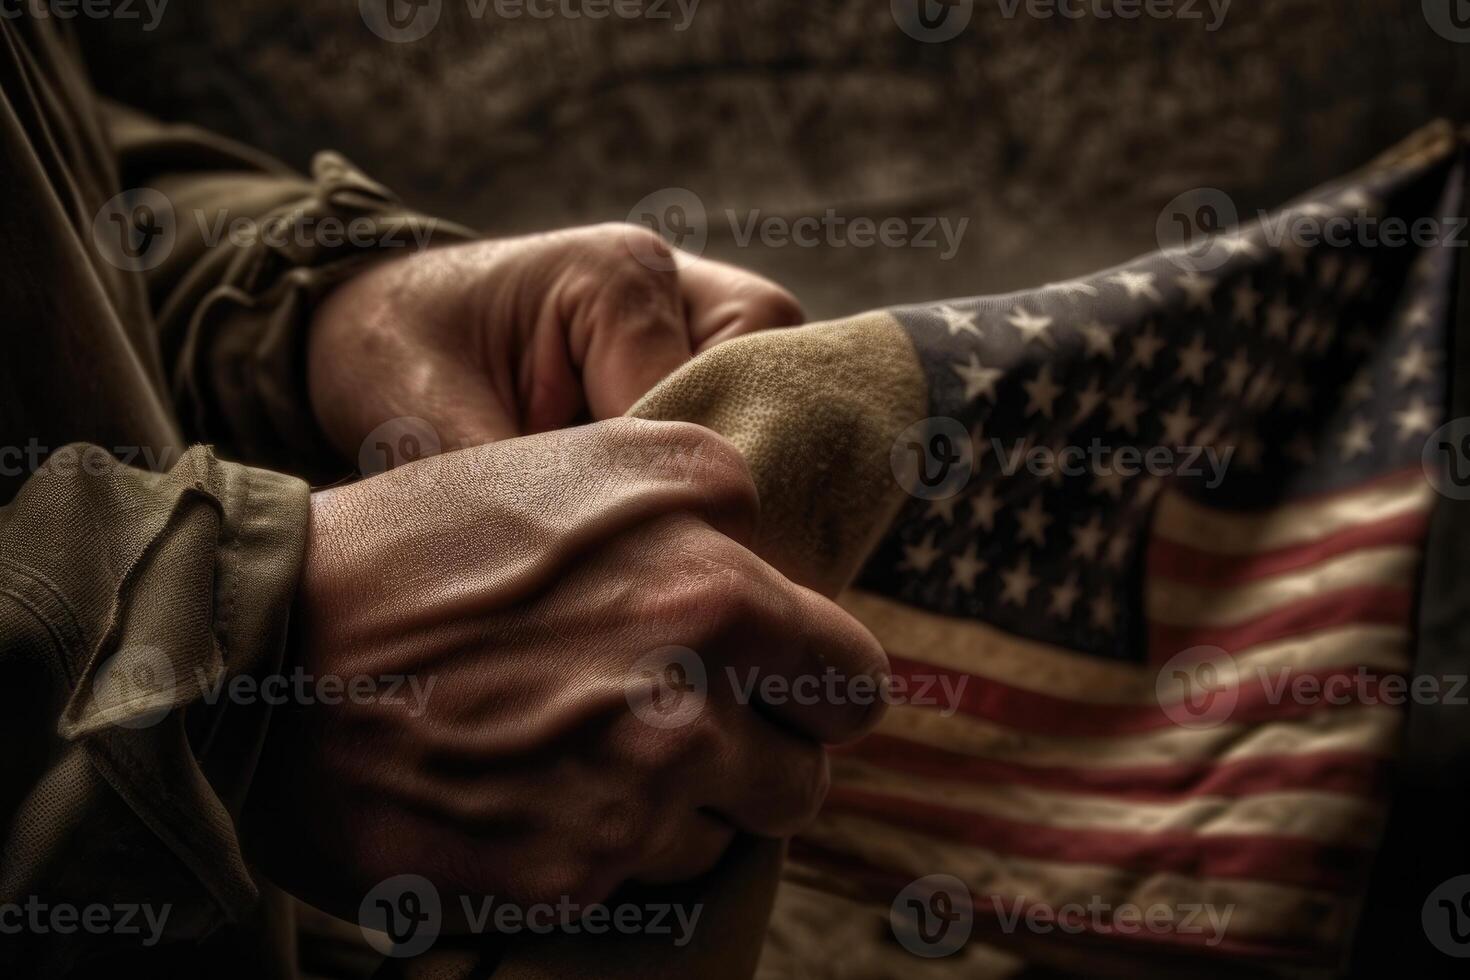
495, 314, 928, 980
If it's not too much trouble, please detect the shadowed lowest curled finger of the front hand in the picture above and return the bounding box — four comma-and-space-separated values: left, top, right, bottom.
700, 711, 832, 837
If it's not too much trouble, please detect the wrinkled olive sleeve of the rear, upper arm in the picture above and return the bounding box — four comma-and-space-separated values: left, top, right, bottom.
103, 103, 472, 476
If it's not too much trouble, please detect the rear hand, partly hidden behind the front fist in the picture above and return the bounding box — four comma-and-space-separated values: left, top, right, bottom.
309, 223, 803, 458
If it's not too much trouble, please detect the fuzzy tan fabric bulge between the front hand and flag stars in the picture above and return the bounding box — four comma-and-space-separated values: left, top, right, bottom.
628, 313, 929, 598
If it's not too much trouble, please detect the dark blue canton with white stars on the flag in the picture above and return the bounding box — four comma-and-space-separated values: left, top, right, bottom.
858, 130, 1466, 663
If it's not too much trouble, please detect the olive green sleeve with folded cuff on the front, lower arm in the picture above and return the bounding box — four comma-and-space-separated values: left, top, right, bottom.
0, 445, 309, 974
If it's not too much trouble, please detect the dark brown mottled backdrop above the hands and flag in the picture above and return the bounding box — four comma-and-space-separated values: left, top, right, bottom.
90, 0, 1470, 316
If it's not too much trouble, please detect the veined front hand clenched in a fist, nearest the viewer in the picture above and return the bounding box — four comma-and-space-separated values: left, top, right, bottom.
245, 419, 886, 918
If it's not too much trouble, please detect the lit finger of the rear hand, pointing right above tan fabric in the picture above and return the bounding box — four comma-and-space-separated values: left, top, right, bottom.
675, 251, 806, 351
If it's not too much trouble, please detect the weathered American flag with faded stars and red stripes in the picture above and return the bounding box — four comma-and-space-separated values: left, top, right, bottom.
775, 126, 1464, 976
